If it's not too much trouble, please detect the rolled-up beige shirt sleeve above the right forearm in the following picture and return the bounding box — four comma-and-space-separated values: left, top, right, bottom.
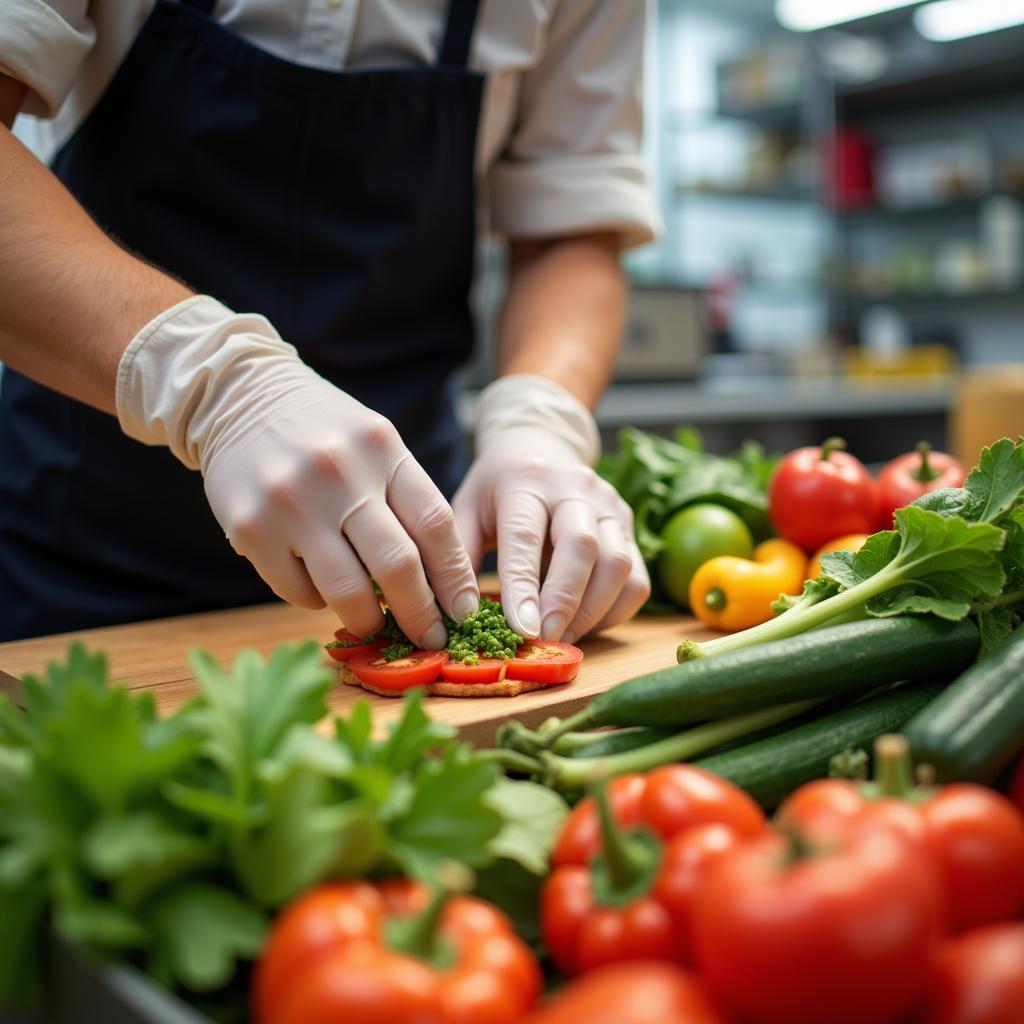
488, 0, 658, 246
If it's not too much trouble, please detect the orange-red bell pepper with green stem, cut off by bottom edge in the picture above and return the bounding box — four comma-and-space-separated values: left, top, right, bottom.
253, 881, 542, 1024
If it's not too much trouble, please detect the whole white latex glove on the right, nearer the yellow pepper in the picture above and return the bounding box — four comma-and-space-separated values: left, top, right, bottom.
453, 374, 650, 643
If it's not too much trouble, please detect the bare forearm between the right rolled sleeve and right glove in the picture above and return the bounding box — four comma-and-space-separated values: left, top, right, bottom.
498, 234, 627, 409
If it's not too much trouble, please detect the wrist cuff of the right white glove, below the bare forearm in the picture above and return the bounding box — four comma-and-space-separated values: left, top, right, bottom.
476, 374, 601, 466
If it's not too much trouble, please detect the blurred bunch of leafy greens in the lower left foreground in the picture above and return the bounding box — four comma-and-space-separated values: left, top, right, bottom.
0, 642, 565, 1016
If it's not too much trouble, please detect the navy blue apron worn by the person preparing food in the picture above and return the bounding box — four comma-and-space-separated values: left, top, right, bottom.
0, 0, 483, 640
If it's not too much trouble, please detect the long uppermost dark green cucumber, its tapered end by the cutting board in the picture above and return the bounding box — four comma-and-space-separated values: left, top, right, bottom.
548, 615, 978, 742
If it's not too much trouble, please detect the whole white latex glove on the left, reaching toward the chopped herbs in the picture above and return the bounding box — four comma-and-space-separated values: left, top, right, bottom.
117, 296, 479, 648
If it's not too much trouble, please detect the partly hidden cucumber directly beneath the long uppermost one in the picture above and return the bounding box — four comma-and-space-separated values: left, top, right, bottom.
693, 679, 947, 808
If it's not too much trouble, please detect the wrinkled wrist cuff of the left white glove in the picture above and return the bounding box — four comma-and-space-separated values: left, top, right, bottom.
115, 295, 298, 469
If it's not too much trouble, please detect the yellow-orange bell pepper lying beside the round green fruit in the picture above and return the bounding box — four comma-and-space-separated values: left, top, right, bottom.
689, 540, 807, 633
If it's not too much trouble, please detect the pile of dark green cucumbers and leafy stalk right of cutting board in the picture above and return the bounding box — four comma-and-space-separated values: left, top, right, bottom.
501, 439, 1024, 794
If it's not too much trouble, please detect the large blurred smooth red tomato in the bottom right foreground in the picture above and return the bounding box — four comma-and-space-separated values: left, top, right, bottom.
695, 826, 941, 1024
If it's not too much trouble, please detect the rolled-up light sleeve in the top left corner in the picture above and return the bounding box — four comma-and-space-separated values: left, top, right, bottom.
0, 0, 95, 118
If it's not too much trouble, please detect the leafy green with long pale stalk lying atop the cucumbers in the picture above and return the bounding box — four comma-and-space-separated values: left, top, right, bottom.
687, 438, 1024, 656
